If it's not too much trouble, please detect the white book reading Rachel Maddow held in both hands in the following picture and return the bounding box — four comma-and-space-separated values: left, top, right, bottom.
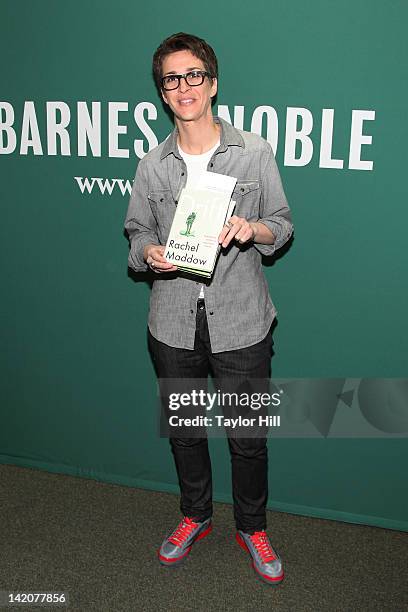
164, 172, 236, 278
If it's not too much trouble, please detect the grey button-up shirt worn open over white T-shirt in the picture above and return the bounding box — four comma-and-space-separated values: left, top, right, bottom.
125, 117, 293, 353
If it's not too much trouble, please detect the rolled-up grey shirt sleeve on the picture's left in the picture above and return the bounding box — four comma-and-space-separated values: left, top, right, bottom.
125, 160, 159, 272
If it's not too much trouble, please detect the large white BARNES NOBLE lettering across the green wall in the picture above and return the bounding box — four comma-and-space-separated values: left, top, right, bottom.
0, 100, 375, 170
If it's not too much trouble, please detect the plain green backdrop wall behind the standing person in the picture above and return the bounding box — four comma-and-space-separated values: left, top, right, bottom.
0, 0, 408, 530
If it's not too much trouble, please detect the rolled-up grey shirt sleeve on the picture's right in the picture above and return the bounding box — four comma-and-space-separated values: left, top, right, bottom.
254, 143, 293, 256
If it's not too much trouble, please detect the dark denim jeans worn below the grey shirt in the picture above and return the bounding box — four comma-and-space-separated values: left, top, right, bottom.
148, 300, 273, 533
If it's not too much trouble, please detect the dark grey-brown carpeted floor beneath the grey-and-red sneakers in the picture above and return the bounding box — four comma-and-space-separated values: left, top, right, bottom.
0, 465, 408, 612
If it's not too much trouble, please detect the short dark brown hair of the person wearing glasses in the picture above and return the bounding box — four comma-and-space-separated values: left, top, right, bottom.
153, 32, 218, 90
